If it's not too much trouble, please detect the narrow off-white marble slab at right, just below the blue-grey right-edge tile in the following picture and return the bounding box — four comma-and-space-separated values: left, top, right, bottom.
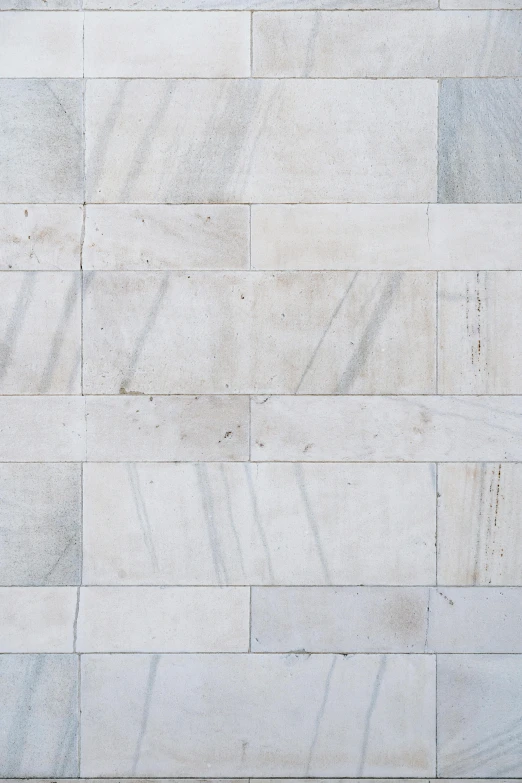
252, 204, 522, 270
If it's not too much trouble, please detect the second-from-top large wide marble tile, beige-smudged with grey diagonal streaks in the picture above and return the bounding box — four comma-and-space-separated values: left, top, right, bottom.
83, 272, 436, 394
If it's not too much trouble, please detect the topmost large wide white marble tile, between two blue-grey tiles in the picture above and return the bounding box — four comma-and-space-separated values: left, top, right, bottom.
86, 79, 437, 203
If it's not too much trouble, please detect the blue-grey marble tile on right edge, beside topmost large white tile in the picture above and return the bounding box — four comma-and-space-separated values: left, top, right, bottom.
438, 79, 522, 202
